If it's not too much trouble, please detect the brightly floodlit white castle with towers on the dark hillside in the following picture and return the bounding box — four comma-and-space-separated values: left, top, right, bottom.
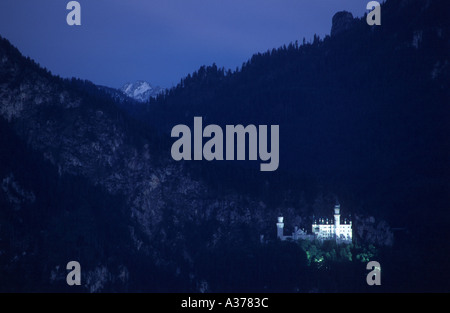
277, 204, 353, 243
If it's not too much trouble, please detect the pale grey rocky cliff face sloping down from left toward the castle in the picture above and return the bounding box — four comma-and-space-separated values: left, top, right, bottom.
0, 40, 272, 291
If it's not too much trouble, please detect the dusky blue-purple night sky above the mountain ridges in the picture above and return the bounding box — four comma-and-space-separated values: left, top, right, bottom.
0, 0, 368, 87
